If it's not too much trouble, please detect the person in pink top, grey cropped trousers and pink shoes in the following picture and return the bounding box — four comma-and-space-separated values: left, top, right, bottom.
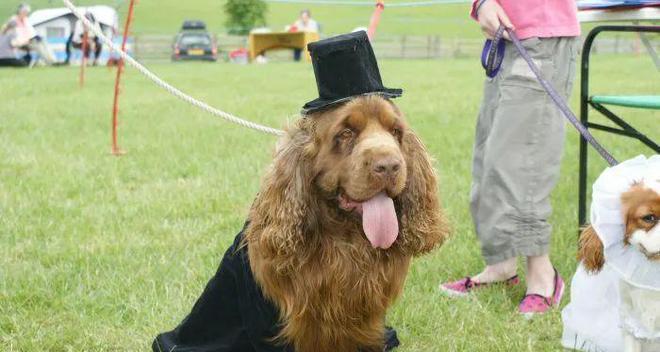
440, 0, 580, 315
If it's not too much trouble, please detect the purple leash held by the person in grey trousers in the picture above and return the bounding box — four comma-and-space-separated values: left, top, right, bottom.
481, 26, 618, 166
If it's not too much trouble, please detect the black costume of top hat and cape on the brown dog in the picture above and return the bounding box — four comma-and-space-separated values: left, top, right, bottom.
152, 31, 402, 352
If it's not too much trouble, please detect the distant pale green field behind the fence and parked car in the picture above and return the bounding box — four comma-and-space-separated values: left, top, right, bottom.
0, 0, 481, 38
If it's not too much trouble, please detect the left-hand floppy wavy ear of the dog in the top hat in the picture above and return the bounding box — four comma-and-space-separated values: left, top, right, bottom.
246, 118, 318, 273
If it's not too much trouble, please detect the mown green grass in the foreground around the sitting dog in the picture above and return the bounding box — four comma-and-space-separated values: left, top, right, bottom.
0, 54, 660, 352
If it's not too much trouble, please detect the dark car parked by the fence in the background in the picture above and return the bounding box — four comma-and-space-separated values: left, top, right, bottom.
172, 21, 218, 61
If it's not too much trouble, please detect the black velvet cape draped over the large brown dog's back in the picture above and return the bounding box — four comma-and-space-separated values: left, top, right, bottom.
152, 227, 399, 352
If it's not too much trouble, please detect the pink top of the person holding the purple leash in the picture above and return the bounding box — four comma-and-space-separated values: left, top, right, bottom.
470, 0, 580, 39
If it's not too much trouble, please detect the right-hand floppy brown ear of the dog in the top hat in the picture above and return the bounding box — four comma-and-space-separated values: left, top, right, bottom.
397, 129, 449, 255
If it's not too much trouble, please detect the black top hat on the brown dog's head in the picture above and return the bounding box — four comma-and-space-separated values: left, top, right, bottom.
302, 31, 403, 114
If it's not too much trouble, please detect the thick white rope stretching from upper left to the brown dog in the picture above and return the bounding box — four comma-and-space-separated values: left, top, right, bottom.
62, 0, 284, 136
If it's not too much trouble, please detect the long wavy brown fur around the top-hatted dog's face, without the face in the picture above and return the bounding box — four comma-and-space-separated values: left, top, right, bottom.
245, 96, 448, 352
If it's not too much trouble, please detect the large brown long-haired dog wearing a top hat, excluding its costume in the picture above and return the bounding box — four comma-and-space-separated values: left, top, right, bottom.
245, 95, 448, 352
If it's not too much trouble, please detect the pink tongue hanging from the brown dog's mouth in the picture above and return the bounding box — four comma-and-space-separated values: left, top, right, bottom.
362, 193, 399, 249
